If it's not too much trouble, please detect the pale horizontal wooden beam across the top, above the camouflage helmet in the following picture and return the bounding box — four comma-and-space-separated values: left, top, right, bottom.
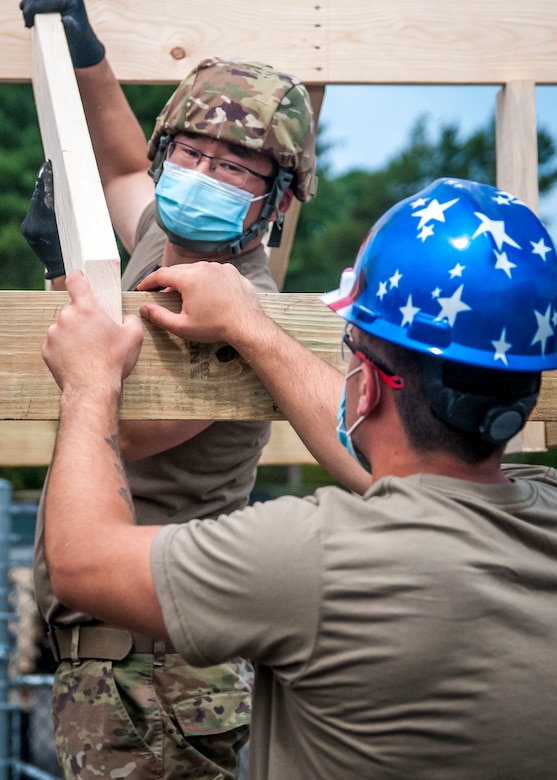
4, 0, 557, 85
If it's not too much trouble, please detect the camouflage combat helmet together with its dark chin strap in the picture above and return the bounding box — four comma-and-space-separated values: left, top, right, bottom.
148, 57, 316, 254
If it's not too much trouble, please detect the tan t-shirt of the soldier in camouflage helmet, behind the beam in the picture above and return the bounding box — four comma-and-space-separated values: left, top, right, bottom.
33, 202, 277, 625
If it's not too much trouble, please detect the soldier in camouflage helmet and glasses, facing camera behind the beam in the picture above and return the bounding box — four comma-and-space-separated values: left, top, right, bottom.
21, 0, 316, 780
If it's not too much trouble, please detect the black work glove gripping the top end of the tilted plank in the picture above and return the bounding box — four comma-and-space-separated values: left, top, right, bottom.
19, 0, 104, 68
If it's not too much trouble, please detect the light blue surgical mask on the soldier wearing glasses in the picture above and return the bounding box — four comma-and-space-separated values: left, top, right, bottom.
155, 165, 267, 247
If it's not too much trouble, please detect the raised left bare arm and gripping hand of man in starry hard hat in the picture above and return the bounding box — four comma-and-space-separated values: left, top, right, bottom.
42, 271, 166, 638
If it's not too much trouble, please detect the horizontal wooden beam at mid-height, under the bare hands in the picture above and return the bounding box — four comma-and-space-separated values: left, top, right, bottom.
0, 291, 342, 420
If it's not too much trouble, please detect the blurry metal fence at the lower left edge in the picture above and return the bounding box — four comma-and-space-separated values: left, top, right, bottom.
0, 479, 62, 780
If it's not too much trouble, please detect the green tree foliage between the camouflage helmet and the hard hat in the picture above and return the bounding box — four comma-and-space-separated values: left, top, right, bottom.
284, 112, 557, 292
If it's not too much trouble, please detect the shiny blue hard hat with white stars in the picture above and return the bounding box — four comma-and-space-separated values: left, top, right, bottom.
321, 178, 557, 371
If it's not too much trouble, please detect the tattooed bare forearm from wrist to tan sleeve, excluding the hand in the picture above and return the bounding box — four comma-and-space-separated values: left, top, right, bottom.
45, 395, 167, 639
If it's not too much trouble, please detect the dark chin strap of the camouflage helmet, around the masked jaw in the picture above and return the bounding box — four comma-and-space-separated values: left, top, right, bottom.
149, 134, 294, 255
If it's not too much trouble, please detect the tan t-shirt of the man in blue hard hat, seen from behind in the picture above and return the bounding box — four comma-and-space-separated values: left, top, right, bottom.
151, 466, 557, 780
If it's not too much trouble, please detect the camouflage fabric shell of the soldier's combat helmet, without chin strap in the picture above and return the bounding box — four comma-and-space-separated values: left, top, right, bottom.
148, 57, 316, 201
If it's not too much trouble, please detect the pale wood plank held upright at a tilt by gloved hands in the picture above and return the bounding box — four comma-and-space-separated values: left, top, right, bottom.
33, 14, 122, 322
